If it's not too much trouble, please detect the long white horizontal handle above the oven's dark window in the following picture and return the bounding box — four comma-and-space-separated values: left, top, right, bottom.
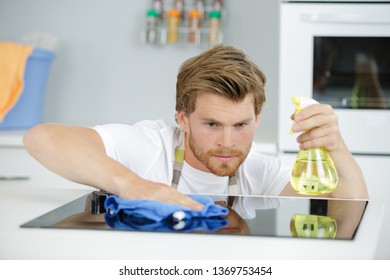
300, 13, 390, 24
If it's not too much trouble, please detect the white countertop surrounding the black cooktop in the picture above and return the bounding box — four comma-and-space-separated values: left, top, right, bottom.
0, 182, 384, 260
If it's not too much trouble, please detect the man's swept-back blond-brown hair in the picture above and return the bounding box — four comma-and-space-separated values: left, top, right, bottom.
176, 45, 266, 115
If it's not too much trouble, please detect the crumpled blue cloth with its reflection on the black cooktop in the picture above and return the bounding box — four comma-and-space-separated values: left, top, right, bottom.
104, 195, 229, 230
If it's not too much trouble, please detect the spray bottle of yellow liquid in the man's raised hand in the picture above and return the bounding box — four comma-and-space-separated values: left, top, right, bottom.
290, 96, 338, 195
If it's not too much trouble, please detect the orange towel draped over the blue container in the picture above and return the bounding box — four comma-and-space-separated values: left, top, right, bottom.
0, 42, 33, 122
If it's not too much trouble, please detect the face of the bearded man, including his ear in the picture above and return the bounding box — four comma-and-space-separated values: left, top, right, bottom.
178, 93, 260, 176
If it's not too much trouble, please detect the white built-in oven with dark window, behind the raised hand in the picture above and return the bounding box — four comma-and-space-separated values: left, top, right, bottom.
278, 2, 390, 154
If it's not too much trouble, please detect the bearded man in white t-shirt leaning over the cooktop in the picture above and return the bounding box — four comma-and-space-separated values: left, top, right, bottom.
24, 45, 367, 209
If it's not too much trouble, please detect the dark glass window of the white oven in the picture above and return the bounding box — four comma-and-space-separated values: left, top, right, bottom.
313, 36, 390, 110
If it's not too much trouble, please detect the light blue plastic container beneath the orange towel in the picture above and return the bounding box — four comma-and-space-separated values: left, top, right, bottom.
0, 49, 54, 130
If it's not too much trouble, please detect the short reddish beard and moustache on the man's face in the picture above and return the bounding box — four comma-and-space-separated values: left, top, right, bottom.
189, 133, 250, 176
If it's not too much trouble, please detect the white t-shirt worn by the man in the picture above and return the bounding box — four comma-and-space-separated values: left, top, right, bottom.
94, 120, 291, 218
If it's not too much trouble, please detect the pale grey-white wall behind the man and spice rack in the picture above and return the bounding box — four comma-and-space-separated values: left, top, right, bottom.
0, 0, 279, 141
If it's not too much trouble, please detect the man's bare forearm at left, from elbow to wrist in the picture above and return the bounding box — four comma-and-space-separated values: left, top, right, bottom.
23, 124, 136, 194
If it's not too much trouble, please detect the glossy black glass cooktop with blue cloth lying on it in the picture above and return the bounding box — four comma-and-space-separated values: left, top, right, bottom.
21, 191, 368, 240
